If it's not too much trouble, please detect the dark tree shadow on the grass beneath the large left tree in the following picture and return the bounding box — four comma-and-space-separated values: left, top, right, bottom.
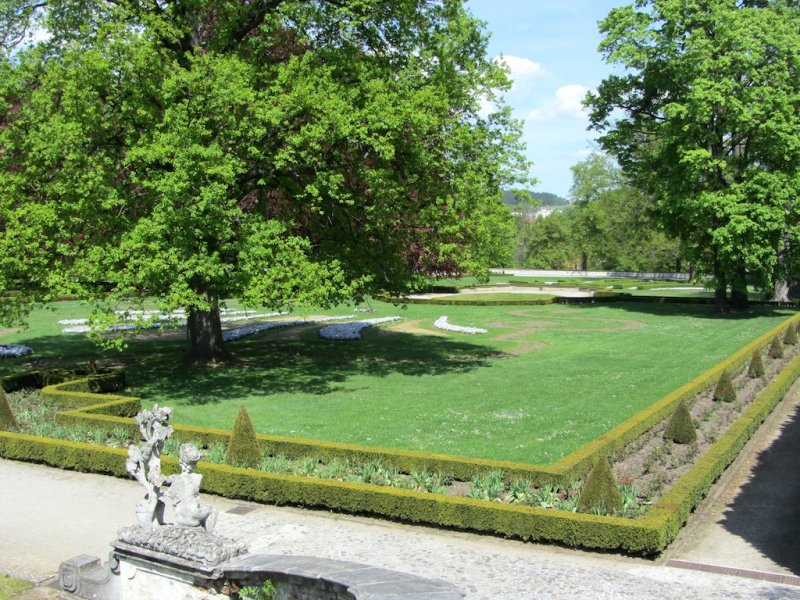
14, 329, 500, 405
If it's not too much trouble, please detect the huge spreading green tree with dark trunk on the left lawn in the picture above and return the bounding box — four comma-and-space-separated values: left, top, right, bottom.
0, 0, 527, 360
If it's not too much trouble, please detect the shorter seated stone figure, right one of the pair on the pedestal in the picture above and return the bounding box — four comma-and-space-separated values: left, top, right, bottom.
164, 444, 217, 532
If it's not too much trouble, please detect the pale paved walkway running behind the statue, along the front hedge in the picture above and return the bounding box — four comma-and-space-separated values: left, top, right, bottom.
0, 460, 800, 600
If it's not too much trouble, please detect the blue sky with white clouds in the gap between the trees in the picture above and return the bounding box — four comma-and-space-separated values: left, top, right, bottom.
467, 0, 632, 196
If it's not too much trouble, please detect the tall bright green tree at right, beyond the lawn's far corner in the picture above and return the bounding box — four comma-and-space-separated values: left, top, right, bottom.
588, 0, 800, 309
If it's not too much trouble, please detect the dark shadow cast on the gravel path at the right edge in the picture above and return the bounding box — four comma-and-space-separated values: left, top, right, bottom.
721, 407, 800, 575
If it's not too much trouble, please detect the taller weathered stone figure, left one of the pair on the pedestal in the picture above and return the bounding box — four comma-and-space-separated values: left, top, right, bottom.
125, 404, 172, 529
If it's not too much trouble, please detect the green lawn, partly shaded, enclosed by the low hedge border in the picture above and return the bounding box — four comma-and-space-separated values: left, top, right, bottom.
0, 302, 792, 464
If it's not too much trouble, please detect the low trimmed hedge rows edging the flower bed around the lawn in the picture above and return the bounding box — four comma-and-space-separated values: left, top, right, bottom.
0, 315, 800, 554
